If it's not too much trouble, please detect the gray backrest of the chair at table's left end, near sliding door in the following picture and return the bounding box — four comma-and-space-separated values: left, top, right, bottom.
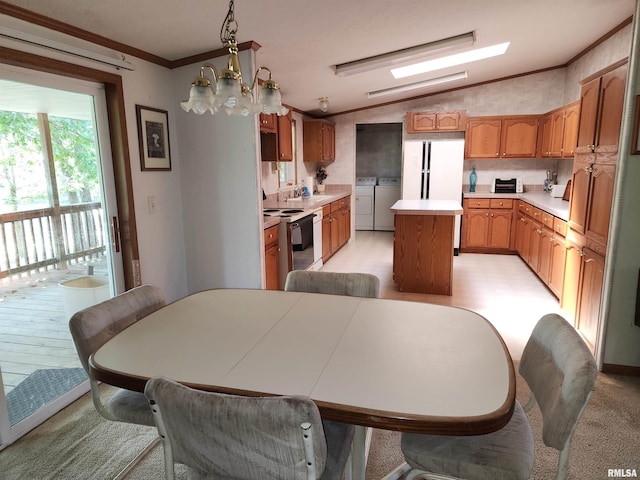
69, 285, 166, 377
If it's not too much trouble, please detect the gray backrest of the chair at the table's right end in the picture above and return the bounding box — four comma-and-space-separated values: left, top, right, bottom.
519, 314, 598, 450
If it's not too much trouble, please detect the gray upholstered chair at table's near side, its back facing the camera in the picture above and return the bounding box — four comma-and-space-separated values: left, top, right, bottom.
145, 377, 354, 480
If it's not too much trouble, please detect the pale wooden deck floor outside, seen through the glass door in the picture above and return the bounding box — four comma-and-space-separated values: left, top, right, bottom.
0, 258, 106, 394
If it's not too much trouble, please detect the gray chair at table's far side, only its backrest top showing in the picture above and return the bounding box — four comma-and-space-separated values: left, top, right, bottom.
284, 270, 380, 298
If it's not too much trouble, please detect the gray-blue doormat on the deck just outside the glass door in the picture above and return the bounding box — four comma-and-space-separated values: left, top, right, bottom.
7, 368, 87, 425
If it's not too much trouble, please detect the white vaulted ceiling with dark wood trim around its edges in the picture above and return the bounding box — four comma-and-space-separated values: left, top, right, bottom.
0, 0, 635, 114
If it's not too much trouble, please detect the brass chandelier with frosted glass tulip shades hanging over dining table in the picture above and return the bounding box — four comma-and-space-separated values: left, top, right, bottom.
180, 0, 289, 117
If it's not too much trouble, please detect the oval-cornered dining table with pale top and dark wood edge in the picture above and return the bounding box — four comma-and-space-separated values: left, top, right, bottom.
89, 288, 515, 480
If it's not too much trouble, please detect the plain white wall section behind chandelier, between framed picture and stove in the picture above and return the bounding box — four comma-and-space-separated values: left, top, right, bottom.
168, 51, 264, 293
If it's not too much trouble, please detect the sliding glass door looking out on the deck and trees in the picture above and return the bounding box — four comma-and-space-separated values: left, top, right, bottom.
0, 66, 124, 448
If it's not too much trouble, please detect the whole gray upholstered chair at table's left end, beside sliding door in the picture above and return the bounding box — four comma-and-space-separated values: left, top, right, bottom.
69, 285, 166, 479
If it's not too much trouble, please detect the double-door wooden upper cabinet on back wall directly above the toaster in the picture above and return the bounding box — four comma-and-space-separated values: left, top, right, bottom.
465, 115, 540, 158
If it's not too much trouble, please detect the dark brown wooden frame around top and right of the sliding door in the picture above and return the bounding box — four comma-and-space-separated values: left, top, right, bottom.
0, 46, 141, 290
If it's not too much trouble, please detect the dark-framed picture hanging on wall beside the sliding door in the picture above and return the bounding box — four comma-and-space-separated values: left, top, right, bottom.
136, 105, 171, 171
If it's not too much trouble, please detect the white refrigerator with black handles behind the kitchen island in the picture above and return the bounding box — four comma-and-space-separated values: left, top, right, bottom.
402, 139, 464, 249
